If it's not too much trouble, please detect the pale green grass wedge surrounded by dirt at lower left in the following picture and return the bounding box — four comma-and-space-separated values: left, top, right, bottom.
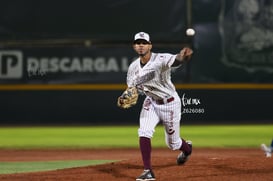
0, 160, 114, 174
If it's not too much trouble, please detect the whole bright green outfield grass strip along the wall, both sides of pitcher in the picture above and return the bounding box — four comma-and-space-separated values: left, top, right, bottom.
0, 125, 273, 149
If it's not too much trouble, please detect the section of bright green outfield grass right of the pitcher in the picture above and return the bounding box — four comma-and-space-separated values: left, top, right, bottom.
182, 125, 273, 148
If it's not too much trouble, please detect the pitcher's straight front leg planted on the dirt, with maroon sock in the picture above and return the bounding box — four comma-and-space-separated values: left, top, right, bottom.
137, 98, 159, 180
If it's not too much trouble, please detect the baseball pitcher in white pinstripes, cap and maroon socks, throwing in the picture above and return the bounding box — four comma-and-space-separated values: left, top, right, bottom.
117, 32, 193, 181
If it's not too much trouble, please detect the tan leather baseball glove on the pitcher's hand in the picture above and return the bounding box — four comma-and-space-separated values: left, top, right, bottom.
117, 87, 138, 109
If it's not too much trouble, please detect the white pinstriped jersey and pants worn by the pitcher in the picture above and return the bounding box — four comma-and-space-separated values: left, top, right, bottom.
127, 53, 182, 150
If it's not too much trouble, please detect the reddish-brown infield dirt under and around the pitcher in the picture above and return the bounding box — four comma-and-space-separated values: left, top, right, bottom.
0, 148, 273, 181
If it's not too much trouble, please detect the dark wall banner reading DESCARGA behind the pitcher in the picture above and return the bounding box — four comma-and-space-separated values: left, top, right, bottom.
0, 45, 187, 84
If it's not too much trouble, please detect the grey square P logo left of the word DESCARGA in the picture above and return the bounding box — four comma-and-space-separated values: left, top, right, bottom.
0, 50, 23, 79
